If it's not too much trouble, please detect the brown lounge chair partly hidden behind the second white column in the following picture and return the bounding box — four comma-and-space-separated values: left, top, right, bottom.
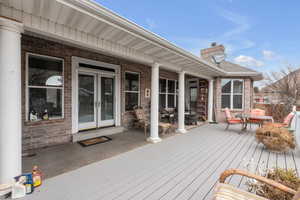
134, 107, 172, 137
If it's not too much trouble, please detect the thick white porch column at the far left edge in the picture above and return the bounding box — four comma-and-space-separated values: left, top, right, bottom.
0, 17, 22, 184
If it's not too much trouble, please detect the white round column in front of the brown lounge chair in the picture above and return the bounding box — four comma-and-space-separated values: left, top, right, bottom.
147, 63, 161, 143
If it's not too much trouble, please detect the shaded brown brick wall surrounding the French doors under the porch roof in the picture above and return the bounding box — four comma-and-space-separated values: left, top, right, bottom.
22, 35, 178, 150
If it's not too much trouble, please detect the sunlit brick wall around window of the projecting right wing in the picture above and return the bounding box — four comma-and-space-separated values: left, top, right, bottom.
214, 77, 253, 122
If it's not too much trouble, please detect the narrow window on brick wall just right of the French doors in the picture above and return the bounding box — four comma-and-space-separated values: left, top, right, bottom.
125, 72, 140, 111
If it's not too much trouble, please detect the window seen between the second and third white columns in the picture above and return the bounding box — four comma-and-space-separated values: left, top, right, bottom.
159, 79, 177, 108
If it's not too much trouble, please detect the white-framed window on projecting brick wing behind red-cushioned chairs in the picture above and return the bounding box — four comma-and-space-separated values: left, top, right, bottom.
221, 79, 244, 109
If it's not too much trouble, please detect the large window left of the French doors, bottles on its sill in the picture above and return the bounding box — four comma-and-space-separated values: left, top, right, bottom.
27, 54, 64, 121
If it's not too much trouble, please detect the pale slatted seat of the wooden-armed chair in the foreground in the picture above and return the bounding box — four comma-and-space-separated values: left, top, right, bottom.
212, 183, 268, 200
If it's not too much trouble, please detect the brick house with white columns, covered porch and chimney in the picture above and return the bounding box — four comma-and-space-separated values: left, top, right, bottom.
0, 0, 262, 183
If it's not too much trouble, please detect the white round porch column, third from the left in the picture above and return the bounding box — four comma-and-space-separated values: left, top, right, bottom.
177, 71, 186, 133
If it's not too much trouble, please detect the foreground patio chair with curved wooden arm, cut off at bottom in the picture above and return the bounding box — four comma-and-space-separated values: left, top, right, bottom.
213, 169, 299, 200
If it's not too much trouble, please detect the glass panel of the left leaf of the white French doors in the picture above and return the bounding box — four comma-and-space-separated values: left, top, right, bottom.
78, 74, 97, 129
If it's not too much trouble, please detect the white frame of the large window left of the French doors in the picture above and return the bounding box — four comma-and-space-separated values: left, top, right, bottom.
25, 53, 65, 123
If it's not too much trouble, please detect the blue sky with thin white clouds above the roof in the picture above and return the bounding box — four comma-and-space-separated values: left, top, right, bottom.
97, 0, 300, 73
